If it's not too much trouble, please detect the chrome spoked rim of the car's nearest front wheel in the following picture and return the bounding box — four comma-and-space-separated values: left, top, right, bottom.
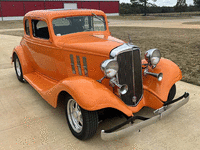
67, 99, 83, 133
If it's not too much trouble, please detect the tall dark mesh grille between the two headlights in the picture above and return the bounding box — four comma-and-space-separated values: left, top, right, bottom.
117, 49, 143, 105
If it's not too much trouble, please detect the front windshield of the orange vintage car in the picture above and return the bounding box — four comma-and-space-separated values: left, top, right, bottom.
52, 16, 106, 36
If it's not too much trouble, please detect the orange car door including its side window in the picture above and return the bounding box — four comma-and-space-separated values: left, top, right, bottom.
27, 19, 57, 79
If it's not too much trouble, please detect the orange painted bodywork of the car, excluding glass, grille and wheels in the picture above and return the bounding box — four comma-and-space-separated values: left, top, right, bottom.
12, 10, 181, 116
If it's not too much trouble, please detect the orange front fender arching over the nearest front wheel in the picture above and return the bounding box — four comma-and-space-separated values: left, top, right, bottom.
43, 76, 133, 116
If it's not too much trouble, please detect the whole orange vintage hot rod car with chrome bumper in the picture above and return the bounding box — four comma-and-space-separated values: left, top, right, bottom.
12, 10, 189, 140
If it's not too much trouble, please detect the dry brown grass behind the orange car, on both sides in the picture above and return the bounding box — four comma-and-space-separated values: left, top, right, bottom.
0, 21, 200, 85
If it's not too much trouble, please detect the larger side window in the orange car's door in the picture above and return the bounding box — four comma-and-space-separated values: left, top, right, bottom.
31, 20, 49, 39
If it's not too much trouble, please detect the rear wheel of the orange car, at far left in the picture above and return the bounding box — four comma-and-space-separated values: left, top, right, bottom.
14, 54, 24, 82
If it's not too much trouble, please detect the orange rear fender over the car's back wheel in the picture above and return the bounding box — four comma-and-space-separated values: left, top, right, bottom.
12, 45, 33, 75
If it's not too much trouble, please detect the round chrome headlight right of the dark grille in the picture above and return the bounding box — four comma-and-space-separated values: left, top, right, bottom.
145, 49, 161, 65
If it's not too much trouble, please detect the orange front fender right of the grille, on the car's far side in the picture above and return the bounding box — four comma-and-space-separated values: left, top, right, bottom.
142, 58, 182, 102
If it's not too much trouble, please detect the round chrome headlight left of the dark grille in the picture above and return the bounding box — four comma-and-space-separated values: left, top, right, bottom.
101, 59, 119, 78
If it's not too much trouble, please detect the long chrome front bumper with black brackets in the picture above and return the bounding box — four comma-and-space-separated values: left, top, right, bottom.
101, 93, 189, 141
